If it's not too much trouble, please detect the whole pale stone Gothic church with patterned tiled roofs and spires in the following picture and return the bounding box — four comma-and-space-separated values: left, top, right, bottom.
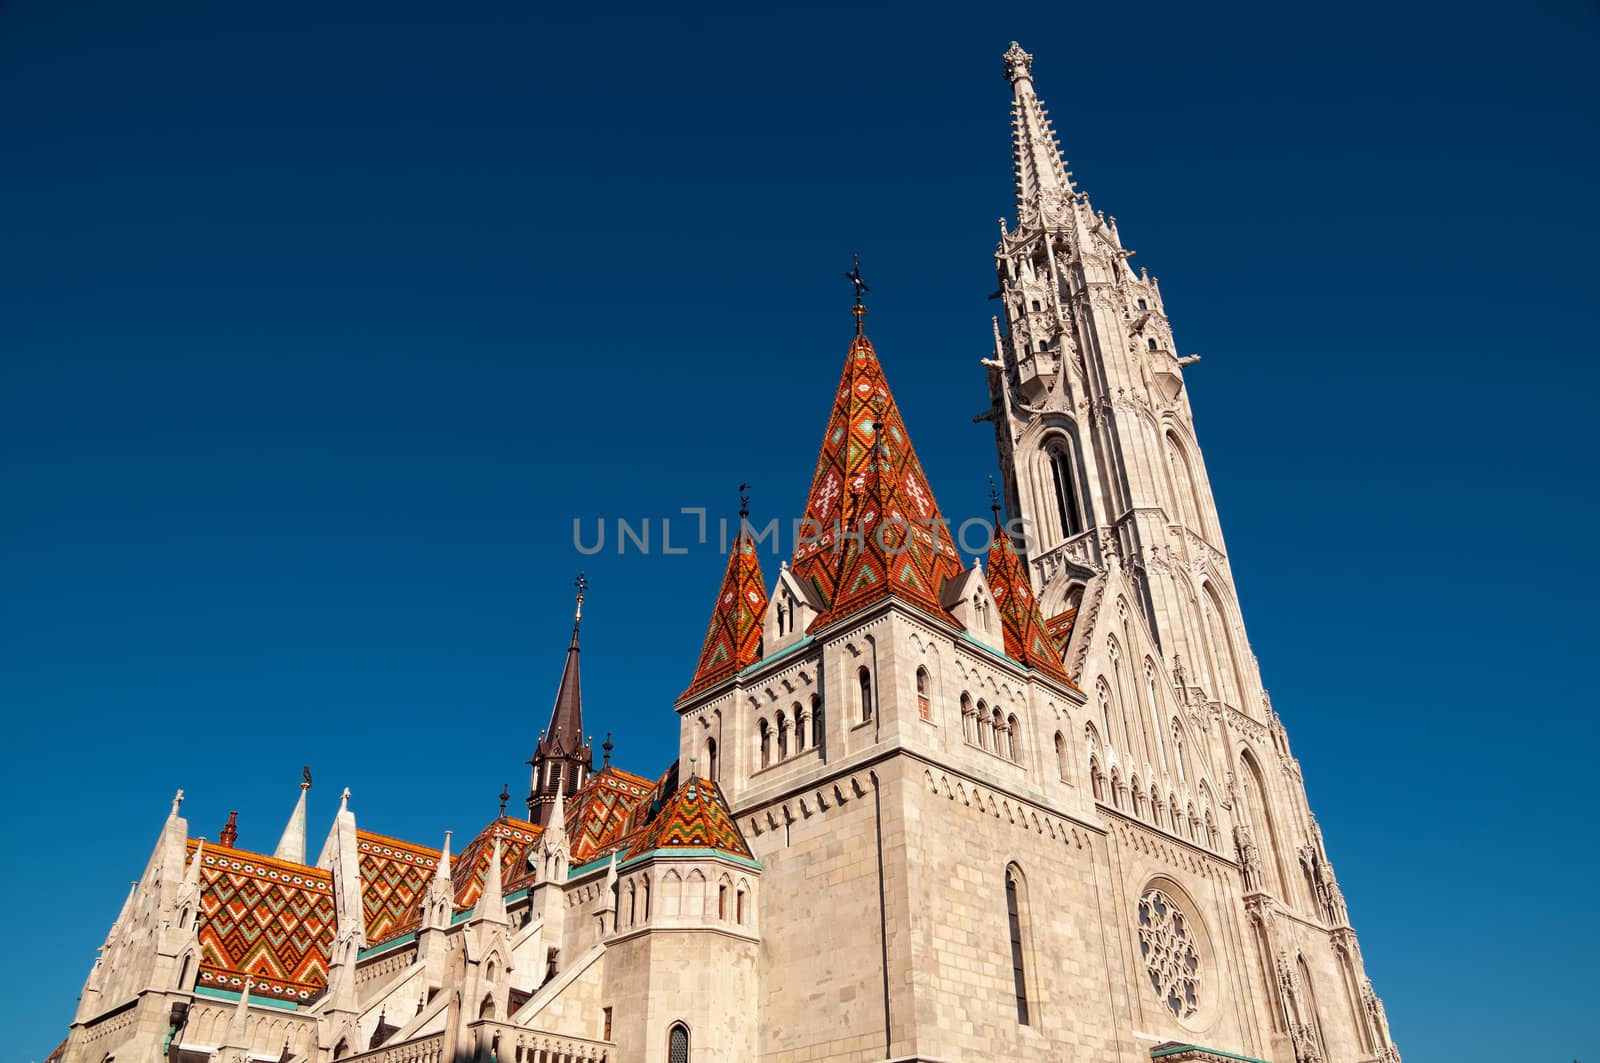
50, 43, 1400, 1063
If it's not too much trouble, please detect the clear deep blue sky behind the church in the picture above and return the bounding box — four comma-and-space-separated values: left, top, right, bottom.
0, 0, 1600, 1063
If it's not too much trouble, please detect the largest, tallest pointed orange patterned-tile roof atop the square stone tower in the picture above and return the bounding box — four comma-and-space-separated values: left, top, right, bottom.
790, 336, 962, 631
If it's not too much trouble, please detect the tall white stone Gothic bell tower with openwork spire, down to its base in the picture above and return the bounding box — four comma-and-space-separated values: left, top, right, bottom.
979, 42, 1400, 1063
